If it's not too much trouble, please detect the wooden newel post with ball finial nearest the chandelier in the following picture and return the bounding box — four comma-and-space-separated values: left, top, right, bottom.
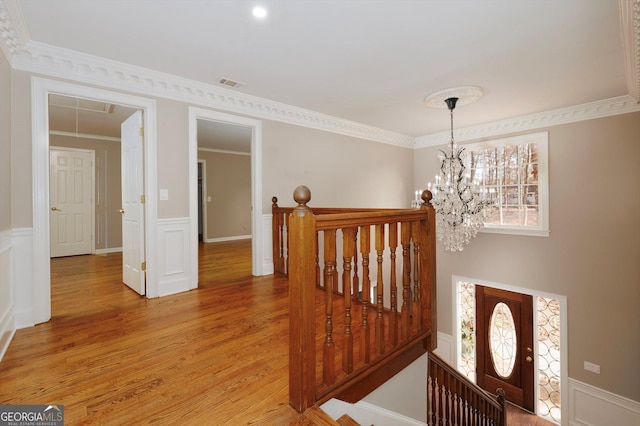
420, 190, 438, 351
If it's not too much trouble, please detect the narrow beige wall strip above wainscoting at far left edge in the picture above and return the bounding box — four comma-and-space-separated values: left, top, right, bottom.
0, 54, 11, 231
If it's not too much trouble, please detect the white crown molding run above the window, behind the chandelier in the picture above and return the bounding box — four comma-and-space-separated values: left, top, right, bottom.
414, 95, 640, 149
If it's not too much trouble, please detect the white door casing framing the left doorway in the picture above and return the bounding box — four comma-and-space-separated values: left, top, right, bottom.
32, 77, 157, 324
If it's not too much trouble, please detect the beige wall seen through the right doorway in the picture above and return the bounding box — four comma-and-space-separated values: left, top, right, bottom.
198, 151, 251, 241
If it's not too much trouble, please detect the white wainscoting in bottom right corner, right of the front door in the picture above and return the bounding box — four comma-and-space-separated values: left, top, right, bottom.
568, 378, 640, 426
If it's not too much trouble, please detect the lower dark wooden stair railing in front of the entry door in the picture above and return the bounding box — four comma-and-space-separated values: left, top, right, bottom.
427, 352, 507, 426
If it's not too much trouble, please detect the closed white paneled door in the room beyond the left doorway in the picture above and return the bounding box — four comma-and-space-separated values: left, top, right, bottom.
49, 148, 94, 257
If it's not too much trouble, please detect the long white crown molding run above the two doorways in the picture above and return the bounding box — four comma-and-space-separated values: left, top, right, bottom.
13, 42, 414, 148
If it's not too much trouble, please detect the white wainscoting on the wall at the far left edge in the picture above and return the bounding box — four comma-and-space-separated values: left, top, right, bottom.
0, 230, 16, 360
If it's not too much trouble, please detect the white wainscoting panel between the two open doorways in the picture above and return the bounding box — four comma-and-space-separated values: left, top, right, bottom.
157, 218, 192, 296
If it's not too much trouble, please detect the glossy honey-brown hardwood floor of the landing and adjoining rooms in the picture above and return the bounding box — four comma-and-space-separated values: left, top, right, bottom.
0, 240, 556, 426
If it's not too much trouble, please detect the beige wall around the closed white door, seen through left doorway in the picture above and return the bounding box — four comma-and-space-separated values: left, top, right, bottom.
49, 135, 122, 250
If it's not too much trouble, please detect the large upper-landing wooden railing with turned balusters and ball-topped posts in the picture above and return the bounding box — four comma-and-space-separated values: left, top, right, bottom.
282, 187, 437, 412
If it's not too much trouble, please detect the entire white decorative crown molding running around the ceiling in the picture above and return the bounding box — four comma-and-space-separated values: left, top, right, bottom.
0, 0, 640, 148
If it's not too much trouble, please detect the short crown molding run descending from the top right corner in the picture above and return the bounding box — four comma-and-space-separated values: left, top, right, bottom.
618, 0, 640, 102
